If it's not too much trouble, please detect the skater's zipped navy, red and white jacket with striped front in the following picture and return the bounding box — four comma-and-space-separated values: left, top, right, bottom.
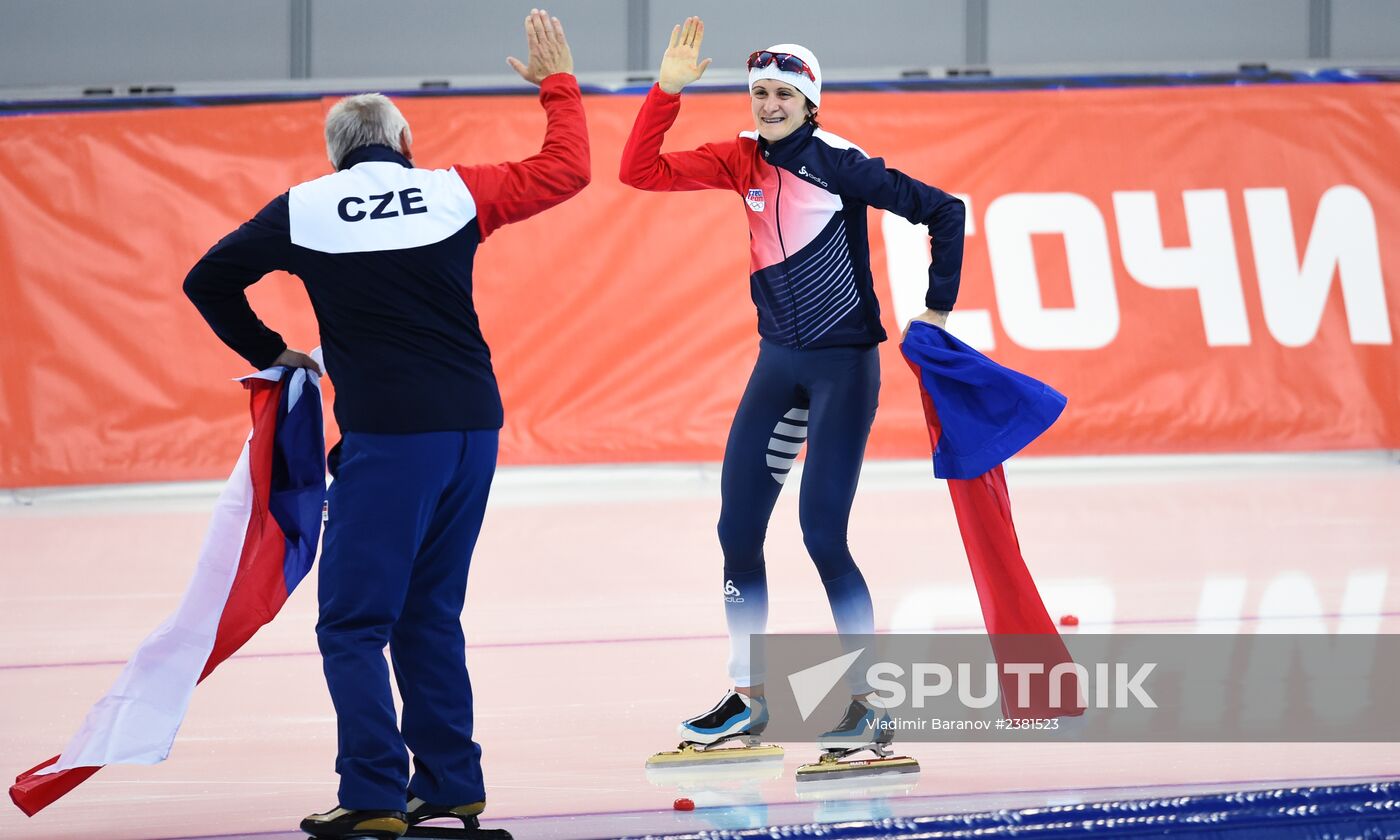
622, 85, 965, 347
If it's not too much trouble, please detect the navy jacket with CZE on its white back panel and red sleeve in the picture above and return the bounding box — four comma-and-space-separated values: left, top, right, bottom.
185, 73, 588, 434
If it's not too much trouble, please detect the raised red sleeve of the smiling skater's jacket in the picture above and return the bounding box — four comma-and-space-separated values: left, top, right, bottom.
620, 84, 739, 192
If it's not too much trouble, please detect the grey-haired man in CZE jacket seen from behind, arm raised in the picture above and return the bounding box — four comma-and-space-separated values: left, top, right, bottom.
185, 11, 588, 837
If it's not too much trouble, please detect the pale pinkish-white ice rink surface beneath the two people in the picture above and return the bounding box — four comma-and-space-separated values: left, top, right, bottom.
0, 454, 1400, 840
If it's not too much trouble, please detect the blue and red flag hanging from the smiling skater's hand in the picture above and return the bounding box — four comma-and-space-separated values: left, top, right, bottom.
900, 321, 1084, 720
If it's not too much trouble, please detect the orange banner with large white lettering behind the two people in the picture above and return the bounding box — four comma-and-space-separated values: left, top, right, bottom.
0, 84, 1400, 487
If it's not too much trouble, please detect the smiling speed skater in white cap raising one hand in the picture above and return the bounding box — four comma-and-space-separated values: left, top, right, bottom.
622, 17, 965, 755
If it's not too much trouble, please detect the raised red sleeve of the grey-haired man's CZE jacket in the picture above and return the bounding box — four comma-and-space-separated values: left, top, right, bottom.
454, 73, 589, 239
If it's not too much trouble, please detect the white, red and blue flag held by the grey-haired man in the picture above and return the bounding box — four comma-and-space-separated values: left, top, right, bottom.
10, 354, 326, 816
